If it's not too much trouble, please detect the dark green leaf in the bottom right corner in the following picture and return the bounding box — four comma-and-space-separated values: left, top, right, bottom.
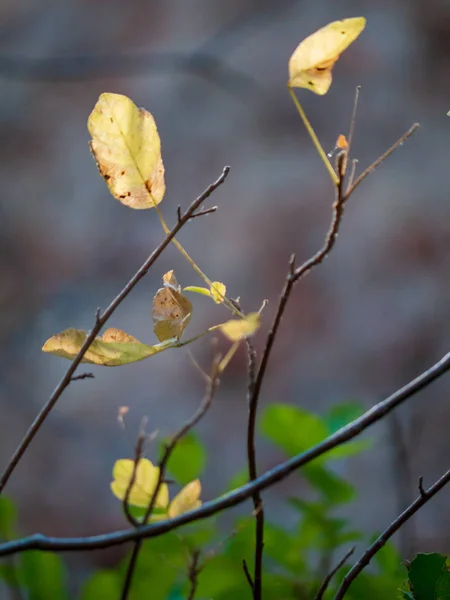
408, 553, 450, 600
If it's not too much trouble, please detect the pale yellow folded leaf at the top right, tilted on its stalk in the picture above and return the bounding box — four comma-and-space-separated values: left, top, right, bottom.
288, 17, 366, 95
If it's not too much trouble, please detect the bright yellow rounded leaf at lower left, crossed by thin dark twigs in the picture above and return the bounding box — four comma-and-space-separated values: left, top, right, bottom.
111, 458, 169, 509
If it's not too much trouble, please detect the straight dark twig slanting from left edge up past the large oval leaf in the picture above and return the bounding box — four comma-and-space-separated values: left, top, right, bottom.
0, 167, 230, 494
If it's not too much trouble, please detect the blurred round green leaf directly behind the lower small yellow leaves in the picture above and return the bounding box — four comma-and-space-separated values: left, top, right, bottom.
168, 432, 206, 485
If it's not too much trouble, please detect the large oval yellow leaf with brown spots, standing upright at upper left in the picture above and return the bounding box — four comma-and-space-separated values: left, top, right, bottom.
88, 94, 166, 209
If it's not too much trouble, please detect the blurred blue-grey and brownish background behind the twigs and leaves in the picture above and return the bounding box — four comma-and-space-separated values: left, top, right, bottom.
0, 0, 450, 592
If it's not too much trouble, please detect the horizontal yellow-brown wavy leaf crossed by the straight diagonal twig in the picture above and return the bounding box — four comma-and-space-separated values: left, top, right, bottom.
42, 328, 177, 367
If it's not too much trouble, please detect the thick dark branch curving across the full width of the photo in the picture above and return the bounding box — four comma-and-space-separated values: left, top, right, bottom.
0, 352, 450, 556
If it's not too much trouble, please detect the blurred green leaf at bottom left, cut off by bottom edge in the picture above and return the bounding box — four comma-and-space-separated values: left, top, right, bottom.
20, 550, 67, 600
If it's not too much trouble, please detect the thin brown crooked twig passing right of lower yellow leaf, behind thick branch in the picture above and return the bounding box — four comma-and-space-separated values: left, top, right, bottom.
121, 360, 219, 600
